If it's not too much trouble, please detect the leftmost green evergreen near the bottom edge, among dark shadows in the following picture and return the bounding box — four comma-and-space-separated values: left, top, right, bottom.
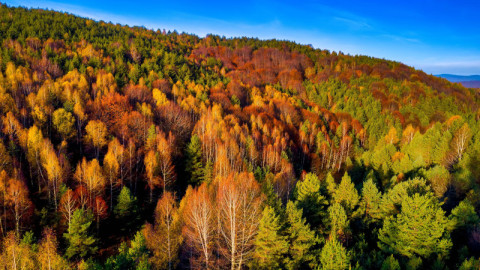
63, 209, 97, 258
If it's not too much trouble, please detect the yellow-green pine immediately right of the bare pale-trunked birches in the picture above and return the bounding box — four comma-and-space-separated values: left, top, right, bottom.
253, 206, 288, 269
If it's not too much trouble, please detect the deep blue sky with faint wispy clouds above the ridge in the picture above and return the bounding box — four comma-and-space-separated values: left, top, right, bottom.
6, 0, 480, 75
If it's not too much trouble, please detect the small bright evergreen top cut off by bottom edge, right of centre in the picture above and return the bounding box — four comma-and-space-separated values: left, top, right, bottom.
320, 237, 350, 270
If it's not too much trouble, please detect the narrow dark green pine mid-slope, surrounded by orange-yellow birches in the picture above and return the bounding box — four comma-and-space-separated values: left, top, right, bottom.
186, 134, 205, 186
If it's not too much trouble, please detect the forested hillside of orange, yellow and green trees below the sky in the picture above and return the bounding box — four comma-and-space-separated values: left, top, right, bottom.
0, 5, 480, 269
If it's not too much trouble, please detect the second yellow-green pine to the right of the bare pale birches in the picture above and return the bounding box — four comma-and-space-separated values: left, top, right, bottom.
285, 201, 317, 269
